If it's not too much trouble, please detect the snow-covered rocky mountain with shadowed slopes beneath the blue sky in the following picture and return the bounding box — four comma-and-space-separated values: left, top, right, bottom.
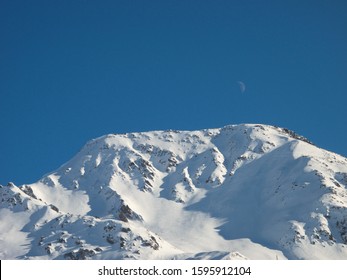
0, 125, 347, 259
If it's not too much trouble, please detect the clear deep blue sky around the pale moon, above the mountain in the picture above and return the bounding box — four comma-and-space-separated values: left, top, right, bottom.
0, 0, 347, 184
